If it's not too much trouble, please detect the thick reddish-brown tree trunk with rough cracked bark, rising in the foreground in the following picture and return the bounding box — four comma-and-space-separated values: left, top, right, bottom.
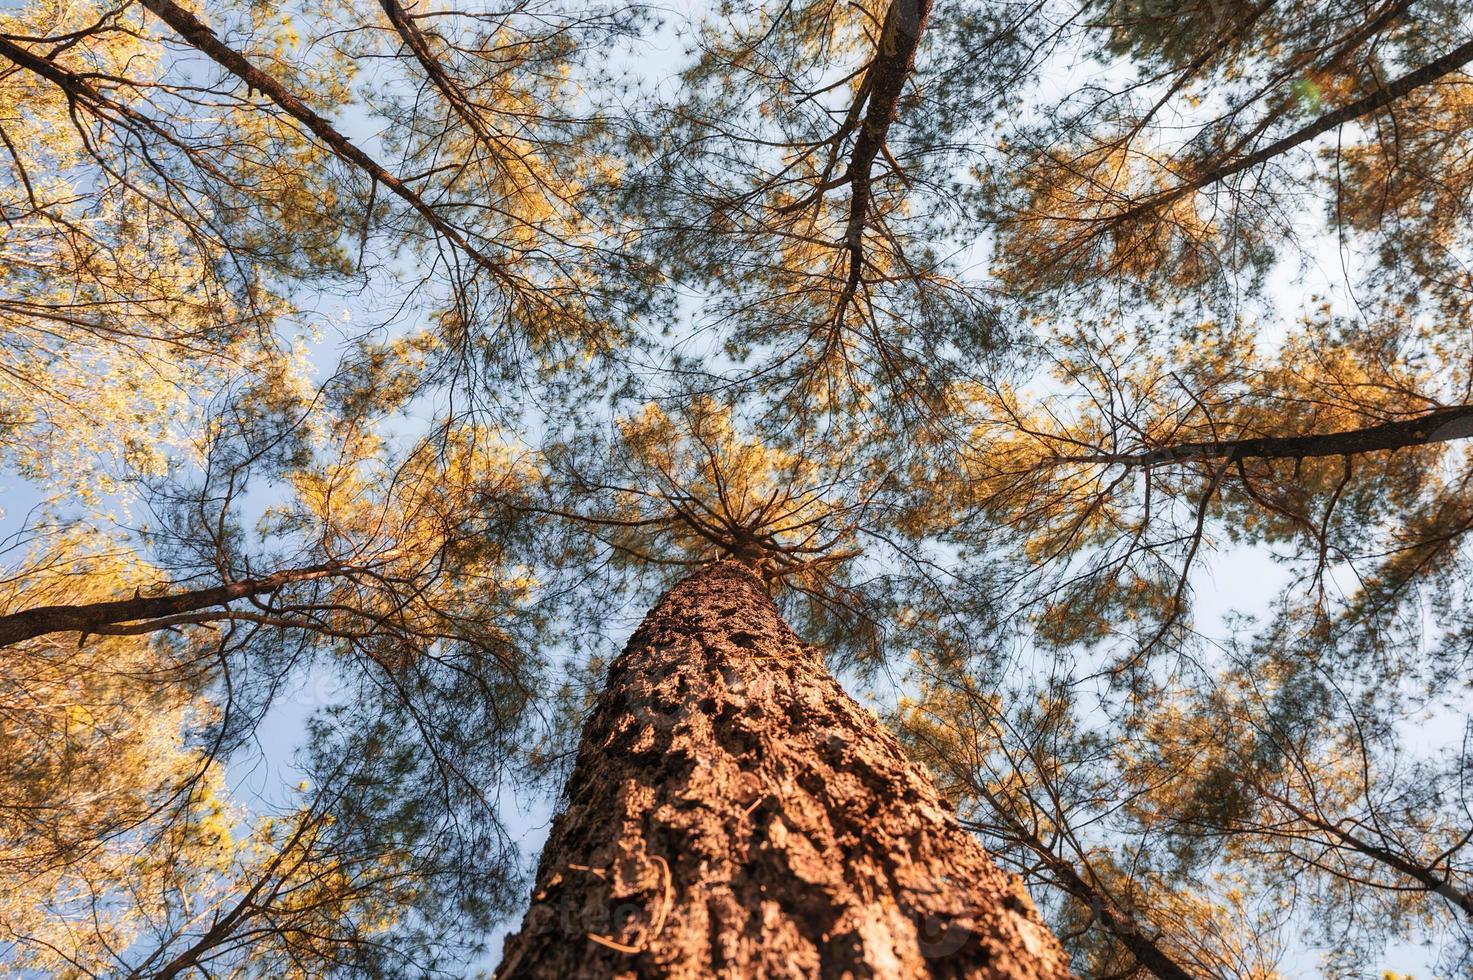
498, 561, 1068, 980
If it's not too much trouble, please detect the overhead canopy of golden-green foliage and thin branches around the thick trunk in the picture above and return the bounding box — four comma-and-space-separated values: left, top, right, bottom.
0, 0, 1473, 980
